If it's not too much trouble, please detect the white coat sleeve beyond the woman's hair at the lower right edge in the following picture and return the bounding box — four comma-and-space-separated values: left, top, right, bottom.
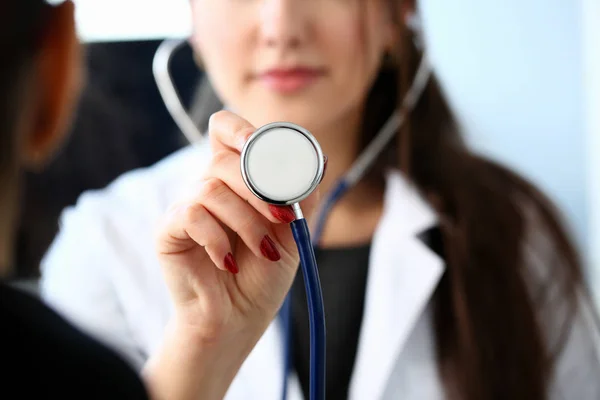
525, 208, 600, 400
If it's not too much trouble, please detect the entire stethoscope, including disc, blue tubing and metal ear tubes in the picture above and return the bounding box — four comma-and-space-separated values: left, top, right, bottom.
153, 40, 431, 400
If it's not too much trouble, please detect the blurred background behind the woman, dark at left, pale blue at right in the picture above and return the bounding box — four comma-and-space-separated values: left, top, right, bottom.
27, 0, 600, 304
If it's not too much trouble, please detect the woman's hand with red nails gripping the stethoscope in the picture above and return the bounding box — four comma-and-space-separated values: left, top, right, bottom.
158, 111, 323, 340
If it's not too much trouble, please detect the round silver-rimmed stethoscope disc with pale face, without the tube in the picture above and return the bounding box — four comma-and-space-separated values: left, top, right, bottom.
241, 122, 324, 205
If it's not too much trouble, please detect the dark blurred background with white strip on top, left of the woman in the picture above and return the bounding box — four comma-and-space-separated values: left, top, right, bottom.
16, 0, 201, 279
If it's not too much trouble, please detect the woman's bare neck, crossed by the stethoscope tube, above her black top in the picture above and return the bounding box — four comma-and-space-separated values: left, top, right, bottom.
313, 110, 383, 247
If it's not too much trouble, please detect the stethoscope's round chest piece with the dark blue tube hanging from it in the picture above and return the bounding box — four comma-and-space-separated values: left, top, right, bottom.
241, 122, 326, 400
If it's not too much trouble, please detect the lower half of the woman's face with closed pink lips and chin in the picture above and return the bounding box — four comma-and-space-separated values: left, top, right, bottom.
191, 0, 395, 130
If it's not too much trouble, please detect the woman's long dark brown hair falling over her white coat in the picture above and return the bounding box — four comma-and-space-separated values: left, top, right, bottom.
188, 0, 589, 400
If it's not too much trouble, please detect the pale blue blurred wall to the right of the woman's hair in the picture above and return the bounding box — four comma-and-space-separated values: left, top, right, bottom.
420, 0, 595, 253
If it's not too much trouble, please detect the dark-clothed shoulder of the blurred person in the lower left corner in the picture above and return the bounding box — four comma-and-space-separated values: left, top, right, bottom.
0, 285, 147, 399
